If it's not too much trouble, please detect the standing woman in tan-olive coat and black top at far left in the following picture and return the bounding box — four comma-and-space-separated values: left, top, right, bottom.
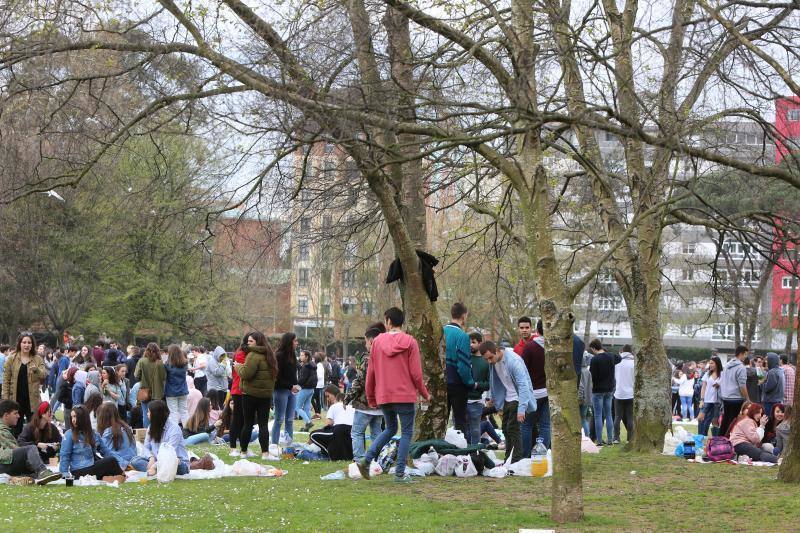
3, 332, 47, 437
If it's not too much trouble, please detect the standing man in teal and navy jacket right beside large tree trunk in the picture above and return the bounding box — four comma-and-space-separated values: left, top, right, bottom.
444, 302, 475, 435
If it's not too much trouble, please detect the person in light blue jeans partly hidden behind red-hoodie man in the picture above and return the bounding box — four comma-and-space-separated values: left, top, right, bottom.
344, 322, 386, 461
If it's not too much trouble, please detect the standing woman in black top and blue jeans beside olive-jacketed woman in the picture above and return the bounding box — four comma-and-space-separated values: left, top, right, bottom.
272, 332, 300, 445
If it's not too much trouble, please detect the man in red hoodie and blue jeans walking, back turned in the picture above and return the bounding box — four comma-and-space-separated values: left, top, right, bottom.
356, 307, 431, 483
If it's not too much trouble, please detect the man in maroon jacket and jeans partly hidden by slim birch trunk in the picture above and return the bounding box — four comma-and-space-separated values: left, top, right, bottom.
520, 320, 550, 457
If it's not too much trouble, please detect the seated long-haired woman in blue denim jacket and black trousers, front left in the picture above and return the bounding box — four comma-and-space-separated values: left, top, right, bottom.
59, 405, 125, 482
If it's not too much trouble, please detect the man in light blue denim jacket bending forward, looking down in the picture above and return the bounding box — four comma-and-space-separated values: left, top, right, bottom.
478, 341, 536, 463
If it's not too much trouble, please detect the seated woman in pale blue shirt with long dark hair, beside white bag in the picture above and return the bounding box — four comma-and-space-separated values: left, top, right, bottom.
131, 400, 214, 476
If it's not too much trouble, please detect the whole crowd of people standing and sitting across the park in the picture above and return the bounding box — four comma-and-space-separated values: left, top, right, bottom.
0, 303, 795, 483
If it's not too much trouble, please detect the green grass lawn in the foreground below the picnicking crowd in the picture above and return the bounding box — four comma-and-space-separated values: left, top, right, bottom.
0, 434, 800, 532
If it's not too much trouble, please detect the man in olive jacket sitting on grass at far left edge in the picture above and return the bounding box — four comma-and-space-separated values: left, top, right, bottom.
0, 400, 61, 485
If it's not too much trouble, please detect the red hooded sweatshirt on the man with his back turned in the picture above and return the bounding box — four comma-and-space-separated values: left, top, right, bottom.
367, 331, 428, 406
